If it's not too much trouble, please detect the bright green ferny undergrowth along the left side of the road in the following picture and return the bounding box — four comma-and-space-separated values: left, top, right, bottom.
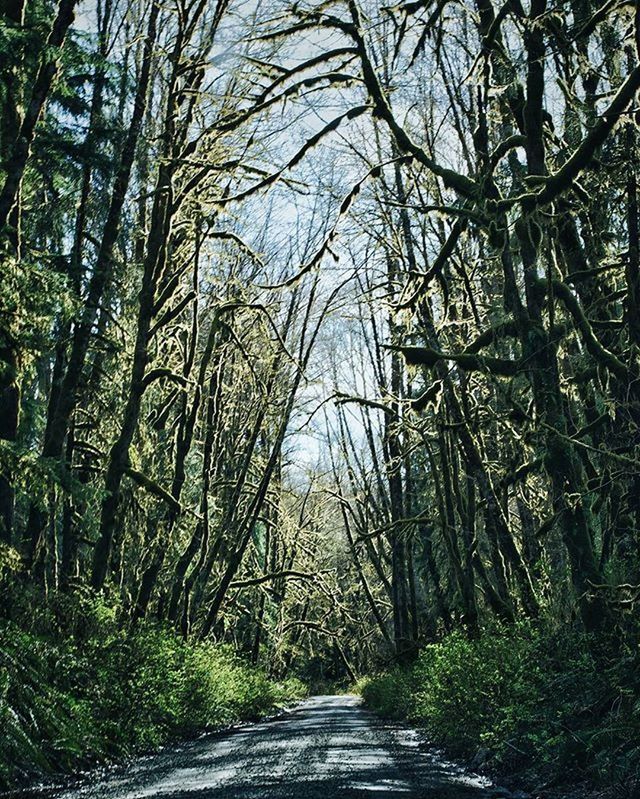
0, 597, 305, 790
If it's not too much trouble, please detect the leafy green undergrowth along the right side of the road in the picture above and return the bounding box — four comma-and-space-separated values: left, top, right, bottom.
357, 624, 640, 796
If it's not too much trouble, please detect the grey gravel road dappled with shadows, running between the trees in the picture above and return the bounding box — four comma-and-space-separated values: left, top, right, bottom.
25, 696, 495, 799
